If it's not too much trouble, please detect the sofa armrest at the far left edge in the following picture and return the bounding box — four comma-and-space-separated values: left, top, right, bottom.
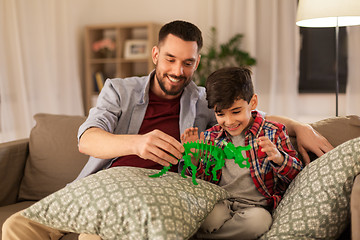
0, 139, 29, 206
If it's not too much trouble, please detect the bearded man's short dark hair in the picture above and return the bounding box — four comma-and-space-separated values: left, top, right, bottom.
158, 20, 203, 52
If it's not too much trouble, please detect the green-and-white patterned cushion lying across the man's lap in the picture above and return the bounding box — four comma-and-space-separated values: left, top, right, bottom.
23, 167, 228, 239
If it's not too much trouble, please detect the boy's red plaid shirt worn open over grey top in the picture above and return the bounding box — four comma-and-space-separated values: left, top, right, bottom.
186, 111, 302, 209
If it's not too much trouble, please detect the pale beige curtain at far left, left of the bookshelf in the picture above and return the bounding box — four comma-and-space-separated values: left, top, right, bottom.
0, 0, 83, 142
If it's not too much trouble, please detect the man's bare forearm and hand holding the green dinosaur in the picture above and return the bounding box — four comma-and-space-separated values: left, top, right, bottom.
79, 127, 185, 166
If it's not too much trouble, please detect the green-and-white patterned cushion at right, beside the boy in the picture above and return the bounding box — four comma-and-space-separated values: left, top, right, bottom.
261, 138, 360, 239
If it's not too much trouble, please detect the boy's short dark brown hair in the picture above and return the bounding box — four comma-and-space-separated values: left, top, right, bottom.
205, 67, 254, 112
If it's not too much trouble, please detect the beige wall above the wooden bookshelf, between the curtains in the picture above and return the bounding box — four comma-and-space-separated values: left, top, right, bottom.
68, 0, 217, 110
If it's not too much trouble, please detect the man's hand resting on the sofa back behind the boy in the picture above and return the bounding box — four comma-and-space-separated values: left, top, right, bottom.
294, 124, 334, 165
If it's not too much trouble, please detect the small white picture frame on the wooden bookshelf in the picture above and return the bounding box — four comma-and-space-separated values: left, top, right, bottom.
124, 39, 149, 59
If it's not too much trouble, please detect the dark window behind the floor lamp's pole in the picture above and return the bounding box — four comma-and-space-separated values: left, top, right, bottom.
299, 27, 347, 93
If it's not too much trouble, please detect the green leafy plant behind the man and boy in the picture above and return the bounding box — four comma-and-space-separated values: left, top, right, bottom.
195, 27, 256, 86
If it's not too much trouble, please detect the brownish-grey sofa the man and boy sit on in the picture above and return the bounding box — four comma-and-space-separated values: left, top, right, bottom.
0, 114, 360, 240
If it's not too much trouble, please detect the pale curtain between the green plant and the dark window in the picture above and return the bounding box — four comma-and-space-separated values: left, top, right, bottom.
202, 0, 298, 118
